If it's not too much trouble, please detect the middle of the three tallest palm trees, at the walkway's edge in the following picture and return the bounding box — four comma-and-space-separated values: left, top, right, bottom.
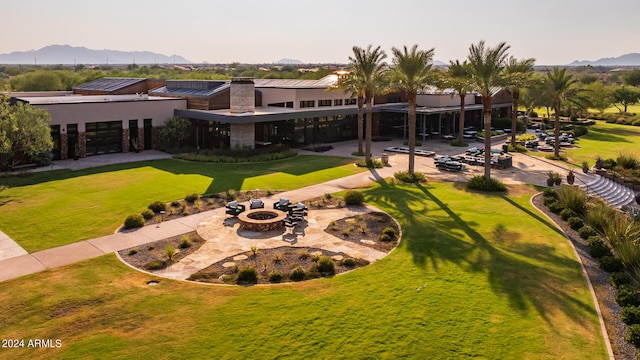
391, 45, 435, 175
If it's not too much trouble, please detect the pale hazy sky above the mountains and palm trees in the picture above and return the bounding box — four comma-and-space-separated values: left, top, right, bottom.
0, 0, 640, 65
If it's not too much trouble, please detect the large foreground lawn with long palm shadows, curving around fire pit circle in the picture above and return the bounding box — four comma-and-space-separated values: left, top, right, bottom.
0, 183, 607, 359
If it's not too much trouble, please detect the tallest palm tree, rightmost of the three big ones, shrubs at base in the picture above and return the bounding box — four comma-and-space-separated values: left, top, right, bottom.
467, 41, 509, 180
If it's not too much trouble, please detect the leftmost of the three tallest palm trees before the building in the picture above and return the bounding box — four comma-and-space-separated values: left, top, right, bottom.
349, 45, 387, 164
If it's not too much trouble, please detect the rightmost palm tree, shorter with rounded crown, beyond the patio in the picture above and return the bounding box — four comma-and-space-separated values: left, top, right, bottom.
542, 67, 578, 158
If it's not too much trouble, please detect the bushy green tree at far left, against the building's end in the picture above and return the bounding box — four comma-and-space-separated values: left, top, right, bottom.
0, 97, 53, 167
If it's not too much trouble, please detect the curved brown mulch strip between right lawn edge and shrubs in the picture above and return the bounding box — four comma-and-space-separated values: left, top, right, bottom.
532, 194, 637, 360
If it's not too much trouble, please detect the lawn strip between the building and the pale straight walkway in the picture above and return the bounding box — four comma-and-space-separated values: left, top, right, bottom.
0, 156, 363, 252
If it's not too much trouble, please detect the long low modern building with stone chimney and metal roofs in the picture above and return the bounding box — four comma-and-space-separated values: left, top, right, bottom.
7, 75, 511, 159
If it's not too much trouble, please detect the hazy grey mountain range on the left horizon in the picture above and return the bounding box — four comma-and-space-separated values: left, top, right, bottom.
0, 45, 191, 65
